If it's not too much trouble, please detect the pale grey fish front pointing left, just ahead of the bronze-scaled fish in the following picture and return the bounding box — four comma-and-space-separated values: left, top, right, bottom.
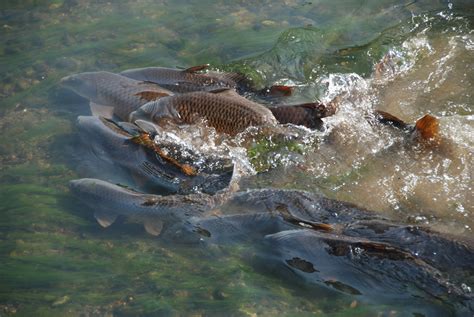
61, 71, 173, 121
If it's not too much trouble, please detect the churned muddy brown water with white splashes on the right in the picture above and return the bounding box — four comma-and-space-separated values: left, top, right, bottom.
231, 12, 474, 236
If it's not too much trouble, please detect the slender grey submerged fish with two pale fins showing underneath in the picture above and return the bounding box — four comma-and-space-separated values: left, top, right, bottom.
70, 178, 235, 235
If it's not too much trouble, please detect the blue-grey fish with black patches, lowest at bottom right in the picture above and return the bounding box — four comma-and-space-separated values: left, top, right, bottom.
258, 229, 474, 316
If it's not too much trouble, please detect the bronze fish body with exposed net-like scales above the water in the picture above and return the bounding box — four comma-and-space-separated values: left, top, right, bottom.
131, 91, 278, 135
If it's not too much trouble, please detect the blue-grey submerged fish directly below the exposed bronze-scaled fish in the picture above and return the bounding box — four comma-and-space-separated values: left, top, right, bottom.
78, 116, 232, 194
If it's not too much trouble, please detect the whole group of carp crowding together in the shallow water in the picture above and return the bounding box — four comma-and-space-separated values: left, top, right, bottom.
61, 65, 474, 315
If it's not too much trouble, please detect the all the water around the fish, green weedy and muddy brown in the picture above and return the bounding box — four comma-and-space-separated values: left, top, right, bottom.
0, 0, 474, 316
